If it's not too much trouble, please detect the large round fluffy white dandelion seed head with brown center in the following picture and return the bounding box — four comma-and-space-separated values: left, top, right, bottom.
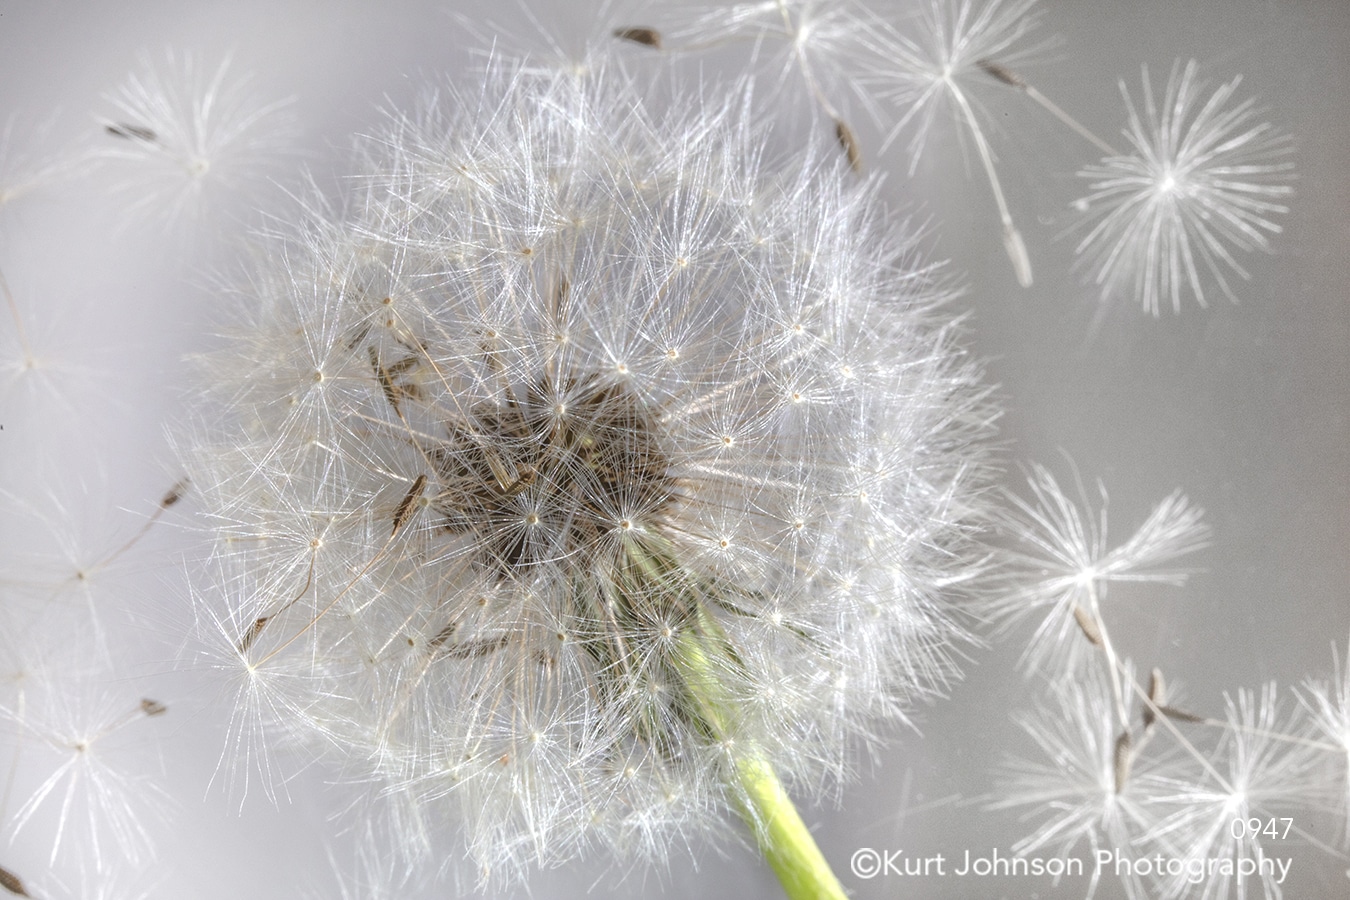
190, 63, 994, 878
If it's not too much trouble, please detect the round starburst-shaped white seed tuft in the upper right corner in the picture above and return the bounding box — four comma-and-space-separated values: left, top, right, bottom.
1075, 61, 1293, 316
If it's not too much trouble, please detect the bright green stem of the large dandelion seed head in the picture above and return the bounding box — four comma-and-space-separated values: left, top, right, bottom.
678, 604, 846, 900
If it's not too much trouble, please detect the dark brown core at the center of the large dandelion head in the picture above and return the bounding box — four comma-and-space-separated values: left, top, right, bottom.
428, 374, 675, 579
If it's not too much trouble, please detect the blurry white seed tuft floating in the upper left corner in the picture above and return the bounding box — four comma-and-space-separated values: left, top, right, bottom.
101, 53, 293, 224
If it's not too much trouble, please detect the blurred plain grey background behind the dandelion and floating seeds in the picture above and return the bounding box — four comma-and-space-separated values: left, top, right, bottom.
0, 0, 1350, 900
